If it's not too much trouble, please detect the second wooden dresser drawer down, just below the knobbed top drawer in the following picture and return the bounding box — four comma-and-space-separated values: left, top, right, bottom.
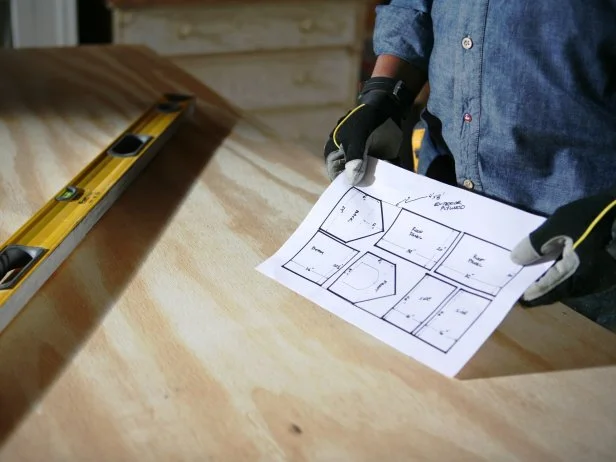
170, 48, 359, 110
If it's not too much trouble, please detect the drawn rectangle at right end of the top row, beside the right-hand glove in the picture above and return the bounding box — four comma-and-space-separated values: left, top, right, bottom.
436, 234, 522, 296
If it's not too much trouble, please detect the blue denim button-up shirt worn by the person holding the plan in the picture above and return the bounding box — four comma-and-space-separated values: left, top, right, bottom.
373, 0, 616, 214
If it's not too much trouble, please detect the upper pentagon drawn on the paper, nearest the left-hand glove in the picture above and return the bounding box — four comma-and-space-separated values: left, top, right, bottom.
321, 188, 383, 242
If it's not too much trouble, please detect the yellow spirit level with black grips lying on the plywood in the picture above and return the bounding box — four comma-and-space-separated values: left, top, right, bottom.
0, 94, 195, 332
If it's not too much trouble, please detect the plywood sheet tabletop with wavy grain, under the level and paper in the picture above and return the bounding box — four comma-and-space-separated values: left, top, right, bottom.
0, 47, 616, 462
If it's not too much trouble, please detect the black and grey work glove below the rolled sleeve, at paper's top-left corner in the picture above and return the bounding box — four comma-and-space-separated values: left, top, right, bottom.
324, 77, 413, 185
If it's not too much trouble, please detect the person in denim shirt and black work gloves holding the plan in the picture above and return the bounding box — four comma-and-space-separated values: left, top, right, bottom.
325, 0, 616, 327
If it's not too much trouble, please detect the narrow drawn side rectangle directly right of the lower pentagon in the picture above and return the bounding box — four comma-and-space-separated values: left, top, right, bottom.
383, 274, 456, 333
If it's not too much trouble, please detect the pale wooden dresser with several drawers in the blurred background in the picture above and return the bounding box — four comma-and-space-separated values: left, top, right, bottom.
108, 0, 375, 155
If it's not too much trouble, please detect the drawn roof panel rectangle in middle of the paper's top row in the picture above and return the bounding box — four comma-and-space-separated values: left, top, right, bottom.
375, 210, 460, 270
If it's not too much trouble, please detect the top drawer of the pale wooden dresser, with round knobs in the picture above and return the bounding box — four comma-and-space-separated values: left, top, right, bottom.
114, 0, 366, 55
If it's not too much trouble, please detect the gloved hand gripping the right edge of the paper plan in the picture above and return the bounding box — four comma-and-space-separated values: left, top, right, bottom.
511, 188, 616, 307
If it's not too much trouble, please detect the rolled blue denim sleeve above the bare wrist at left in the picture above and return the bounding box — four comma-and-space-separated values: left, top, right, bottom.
373, 0, 434, 71
